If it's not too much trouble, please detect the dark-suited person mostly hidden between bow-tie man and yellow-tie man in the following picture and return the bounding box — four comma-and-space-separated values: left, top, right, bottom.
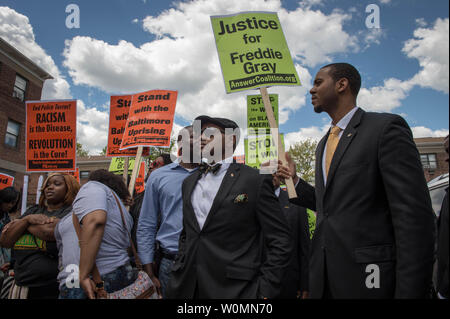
273, 172, 311, 299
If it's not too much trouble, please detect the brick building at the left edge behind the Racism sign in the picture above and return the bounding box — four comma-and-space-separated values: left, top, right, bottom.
0, 38, 52, 210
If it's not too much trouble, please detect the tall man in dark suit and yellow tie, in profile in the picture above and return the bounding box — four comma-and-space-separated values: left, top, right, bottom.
278, 63, 435, 298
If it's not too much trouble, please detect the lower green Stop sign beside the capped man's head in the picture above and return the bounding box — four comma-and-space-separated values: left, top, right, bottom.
244, 134, 284, 169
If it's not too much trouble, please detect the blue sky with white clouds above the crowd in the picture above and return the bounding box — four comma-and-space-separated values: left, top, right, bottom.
0, 0, 449, 154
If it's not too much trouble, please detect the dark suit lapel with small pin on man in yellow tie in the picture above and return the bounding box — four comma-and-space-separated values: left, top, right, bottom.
325, 109, 364, 191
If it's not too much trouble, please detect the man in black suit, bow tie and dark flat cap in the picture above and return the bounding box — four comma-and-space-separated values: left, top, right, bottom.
167, 116, 291, 299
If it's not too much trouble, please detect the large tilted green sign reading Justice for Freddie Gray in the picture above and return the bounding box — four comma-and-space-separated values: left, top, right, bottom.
211, 12, 301, 93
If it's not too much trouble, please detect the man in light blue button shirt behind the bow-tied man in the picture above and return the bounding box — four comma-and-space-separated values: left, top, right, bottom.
136, 126, 198, 297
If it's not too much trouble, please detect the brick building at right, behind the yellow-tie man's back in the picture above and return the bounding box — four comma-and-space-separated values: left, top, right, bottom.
414, 137, 448, 182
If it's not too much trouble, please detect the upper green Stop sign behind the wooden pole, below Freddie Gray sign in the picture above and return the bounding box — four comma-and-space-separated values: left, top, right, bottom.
247, 94, 278, 135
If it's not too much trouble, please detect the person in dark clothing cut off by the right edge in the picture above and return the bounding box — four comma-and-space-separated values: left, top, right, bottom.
435, 135, 450, 299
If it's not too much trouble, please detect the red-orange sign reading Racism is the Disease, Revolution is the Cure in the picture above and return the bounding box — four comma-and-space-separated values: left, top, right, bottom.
25, 100, 77, 172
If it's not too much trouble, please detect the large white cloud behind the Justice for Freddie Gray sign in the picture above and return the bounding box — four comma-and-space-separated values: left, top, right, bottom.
63, 0, 356, 132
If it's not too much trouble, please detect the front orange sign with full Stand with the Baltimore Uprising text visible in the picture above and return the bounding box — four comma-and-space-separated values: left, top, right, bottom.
120, 90, 178, 150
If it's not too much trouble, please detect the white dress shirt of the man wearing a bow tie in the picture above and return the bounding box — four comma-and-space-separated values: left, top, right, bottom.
191, 160, 230, 229
